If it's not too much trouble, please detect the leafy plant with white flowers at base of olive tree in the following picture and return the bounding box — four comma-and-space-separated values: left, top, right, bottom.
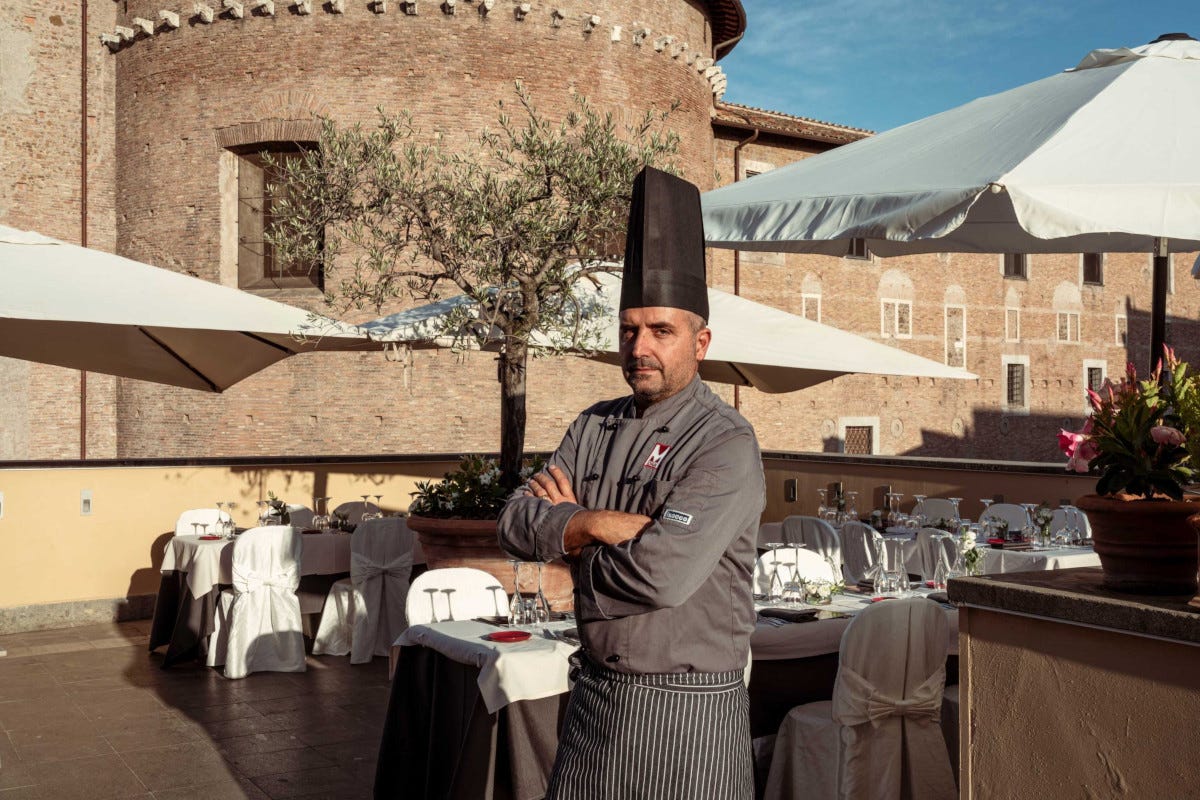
408, 456, 545, 519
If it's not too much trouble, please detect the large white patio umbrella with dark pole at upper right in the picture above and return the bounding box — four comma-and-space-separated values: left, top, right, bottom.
701, 34, 1200, 367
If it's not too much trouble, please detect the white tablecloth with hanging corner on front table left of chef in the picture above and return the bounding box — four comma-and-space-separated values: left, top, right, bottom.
394, 620, 577, 714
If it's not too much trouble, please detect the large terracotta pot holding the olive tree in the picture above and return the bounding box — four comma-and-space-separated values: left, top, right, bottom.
407, 517, 575, 610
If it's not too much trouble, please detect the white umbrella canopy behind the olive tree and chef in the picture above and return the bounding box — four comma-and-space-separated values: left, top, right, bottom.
362, 273, 976, 392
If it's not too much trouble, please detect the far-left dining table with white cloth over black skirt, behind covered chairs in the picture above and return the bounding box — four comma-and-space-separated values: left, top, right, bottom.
149, 530, 350, 668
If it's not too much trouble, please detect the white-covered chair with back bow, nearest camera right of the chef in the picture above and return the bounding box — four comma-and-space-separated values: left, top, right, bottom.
764, 597, 958, 800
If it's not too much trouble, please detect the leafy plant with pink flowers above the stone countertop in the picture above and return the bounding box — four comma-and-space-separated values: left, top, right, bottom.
1058, 348, 1200, 500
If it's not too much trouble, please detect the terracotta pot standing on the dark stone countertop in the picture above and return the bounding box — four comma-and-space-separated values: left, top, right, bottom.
1075, 494, 1200, 595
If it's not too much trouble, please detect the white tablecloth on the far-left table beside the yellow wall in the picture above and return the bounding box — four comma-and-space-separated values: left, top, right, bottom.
162, 534, 350, 597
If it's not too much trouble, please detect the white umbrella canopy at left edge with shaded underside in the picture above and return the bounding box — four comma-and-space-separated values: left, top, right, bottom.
0, 225, 378, 392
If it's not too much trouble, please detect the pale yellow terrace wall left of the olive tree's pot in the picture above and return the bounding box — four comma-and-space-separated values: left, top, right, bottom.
0, 462, 454, 608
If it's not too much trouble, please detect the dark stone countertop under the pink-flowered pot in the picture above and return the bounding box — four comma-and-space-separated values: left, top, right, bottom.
949, 567, 1200, 644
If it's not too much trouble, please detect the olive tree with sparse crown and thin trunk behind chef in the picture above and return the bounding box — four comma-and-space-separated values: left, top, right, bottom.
268, 84, 679, 486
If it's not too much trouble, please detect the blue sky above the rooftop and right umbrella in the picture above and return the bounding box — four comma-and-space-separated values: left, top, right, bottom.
720, 0, 1200, 131
